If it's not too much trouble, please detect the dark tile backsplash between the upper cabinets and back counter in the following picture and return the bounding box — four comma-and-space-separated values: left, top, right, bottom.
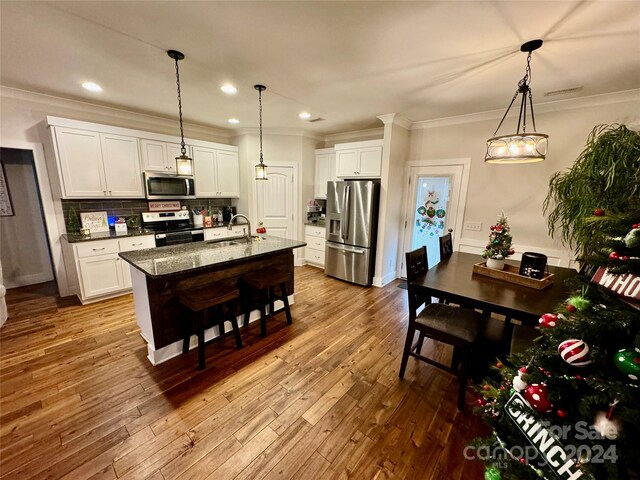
62, 198, 237, 232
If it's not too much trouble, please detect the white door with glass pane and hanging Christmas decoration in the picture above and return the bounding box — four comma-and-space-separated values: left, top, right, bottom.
402, 165, 463, 277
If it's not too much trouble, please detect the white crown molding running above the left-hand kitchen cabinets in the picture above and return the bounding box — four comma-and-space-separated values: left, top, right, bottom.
0, 85, 233, 139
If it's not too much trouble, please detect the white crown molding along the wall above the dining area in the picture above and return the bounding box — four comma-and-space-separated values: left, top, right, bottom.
411, 89, 640, 130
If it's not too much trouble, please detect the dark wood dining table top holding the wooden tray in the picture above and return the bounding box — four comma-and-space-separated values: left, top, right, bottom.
412, 252, 578, 326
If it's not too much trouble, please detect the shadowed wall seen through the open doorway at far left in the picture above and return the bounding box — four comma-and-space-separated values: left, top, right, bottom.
0, 148, 54, 288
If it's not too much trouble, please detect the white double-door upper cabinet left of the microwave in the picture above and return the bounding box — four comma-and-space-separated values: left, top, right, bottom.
51, 127, 144, 198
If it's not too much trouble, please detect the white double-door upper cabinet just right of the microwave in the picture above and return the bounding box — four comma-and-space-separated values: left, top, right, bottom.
192, 147, 240, 198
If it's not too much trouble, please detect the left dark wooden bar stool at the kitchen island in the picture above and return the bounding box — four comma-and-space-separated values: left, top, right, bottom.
179, 283, 242, 370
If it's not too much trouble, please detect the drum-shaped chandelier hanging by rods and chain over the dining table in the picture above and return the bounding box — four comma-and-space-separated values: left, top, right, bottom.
484, 40, 549, 163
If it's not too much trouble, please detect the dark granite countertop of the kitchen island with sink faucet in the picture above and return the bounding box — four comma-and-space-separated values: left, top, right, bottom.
119, 235, 306, 278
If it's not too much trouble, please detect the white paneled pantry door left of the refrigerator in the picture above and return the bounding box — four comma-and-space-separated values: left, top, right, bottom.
252, 166, 296, 239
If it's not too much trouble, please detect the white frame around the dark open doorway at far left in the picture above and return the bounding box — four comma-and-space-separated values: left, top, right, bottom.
0, 139, 71, 297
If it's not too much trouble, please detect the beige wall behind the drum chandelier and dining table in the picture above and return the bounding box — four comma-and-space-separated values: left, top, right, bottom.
408, 91, 640, 265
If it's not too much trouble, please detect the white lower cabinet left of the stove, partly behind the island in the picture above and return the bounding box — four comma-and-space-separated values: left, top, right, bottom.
74, 235, 155, 303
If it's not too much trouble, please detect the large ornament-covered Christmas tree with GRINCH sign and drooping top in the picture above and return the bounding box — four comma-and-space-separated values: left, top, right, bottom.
474, 126, 640, 480
